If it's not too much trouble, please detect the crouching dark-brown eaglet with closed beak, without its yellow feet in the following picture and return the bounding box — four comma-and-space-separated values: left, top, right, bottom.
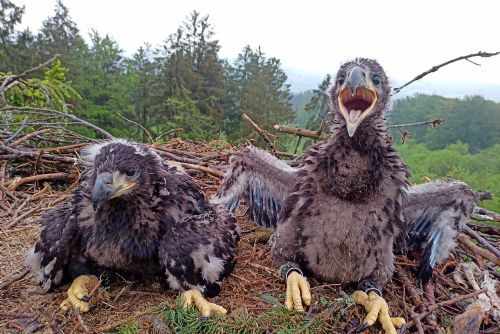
28, 140, 238, 297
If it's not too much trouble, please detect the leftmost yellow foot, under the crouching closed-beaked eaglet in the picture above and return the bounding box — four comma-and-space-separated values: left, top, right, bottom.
60, 275, 99, 312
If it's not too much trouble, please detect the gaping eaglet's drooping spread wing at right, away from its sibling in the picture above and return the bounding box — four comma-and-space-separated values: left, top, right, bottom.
404, 180, 475, 282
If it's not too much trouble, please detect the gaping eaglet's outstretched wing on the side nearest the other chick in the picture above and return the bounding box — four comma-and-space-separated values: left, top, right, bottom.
212, 146, 298, 227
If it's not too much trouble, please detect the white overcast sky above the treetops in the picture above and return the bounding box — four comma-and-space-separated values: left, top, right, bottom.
9, 0, 500, 84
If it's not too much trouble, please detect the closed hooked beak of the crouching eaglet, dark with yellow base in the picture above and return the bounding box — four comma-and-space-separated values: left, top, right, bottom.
92, 171, 135, 210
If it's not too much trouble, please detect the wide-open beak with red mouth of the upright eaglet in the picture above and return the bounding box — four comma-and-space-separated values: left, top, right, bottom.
338, 66, 377, 137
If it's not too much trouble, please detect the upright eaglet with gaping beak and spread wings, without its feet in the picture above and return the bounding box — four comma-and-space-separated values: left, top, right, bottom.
215, 58, 473, 289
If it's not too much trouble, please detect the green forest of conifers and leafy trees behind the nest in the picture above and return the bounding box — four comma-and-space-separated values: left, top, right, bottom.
0, 0, 500, 211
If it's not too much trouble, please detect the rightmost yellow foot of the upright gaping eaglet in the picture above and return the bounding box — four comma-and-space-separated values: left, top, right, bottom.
352, 291, 406, 334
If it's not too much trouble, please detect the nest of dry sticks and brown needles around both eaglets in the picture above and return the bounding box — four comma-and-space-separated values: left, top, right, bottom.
0, 138, 498, 333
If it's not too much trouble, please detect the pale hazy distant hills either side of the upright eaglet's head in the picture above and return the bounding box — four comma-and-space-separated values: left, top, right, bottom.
284, 68, 500, 102
